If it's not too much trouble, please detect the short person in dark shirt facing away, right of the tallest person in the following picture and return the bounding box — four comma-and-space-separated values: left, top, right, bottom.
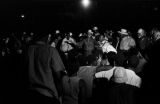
62, 60, 86, 104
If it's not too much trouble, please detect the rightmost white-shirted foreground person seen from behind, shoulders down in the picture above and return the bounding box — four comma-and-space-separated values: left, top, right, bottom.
109, 67, 141, 104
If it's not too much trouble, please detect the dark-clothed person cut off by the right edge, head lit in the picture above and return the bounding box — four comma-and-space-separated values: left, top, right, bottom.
143, 29, 160, 102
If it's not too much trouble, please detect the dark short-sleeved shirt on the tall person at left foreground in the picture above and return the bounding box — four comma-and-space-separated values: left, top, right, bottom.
28, 42, 65, 98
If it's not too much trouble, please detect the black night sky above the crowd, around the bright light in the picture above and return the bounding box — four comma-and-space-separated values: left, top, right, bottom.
0, 0, 160, 31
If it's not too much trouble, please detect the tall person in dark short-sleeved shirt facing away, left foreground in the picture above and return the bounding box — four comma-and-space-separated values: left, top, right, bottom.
27, 34, 65, 104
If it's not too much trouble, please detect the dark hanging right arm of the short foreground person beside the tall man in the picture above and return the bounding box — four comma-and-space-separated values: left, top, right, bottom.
78, 79, 87, 104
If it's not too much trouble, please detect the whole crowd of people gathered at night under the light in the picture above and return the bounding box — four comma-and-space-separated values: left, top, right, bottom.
0, 26, 160, 104
